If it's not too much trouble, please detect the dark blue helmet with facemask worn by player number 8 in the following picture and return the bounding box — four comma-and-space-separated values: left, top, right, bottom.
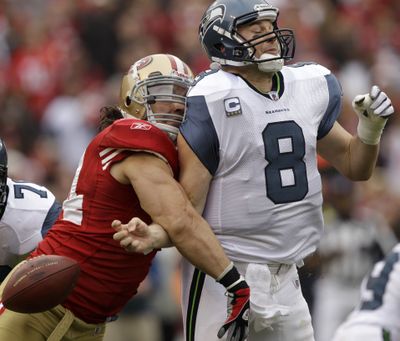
199, 0, 295, 71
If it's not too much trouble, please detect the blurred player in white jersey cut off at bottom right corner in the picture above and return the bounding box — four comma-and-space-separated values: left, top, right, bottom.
333, 244, 400, 341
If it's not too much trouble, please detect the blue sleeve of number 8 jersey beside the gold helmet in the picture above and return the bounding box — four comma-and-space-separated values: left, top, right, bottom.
180, 96, 219, 175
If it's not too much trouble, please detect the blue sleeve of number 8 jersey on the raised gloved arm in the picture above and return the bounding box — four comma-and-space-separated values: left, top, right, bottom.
317, 74, 342, 140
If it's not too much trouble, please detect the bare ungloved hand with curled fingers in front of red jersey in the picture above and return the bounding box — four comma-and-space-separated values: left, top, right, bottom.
111, 217, 153, 255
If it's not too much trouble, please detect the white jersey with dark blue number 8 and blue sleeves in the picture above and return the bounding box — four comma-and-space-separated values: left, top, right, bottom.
181, 64, 341, 264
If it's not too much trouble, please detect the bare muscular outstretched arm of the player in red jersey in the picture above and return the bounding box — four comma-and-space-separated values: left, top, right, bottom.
112, 153, 230, 278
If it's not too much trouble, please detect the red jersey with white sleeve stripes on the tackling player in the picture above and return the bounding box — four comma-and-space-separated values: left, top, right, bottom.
31, 119, 178, 323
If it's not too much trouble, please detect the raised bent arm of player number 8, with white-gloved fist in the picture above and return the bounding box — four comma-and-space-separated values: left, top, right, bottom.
318, 85, 394, 180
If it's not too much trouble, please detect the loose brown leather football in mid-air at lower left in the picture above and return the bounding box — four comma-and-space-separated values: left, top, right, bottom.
1, 255, 80, 314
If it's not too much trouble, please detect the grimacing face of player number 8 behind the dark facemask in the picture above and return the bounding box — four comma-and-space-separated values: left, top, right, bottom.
238, 20, 280, 58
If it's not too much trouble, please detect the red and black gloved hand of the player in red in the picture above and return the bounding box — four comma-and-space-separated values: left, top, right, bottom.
218, 279, 250, 341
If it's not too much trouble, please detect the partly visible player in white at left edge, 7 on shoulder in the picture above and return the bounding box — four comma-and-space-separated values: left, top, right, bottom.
0, 139, 61, 282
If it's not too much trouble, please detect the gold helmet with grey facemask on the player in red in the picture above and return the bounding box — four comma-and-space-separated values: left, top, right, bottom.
119, 54, 193, 141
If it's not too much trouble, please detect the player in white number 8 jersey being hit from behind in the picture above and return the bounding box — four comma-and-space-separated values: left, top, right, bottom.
114, 0, 394, 341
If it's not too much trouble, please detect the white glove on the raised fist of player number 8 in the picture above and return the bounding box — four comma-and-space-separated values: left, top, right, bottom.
352, 85, 394, 145
